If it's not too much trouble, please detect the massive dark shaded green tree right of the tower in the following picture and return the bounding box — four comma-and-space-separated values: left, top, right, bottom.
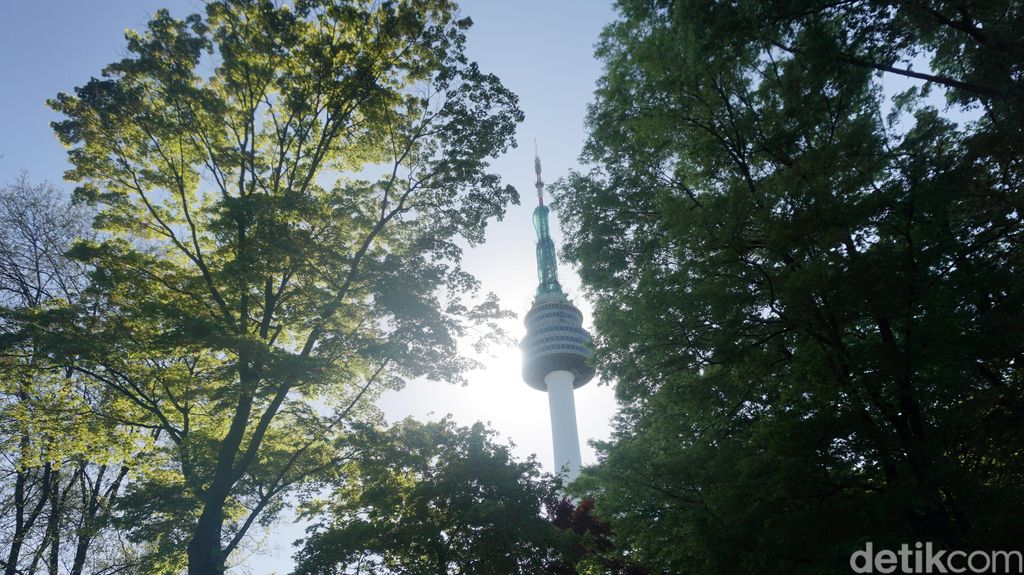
558, 0, 1024, 574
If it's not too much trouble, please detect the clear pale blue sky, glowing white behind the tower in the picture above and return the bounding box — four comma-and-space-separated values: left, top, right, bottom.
0, 0, 614, 575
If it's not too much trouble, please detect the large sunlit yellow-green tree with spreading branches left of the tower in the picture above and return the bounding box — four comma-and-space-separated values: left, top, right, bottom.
22, 0, 522, 575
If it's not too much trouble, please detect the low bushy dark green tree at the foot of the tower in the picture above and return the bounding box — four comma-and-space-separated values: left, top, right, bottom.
296, 419, 574, 575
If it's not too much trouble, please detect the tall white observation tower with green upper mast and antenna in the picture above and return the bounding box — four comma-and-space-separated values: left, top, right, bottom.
519, 150, 594, 481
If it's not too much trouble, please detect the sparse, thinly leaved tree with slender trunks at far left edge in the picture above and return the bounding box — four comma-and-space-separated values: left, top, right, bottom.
0, 175, 140, 575
